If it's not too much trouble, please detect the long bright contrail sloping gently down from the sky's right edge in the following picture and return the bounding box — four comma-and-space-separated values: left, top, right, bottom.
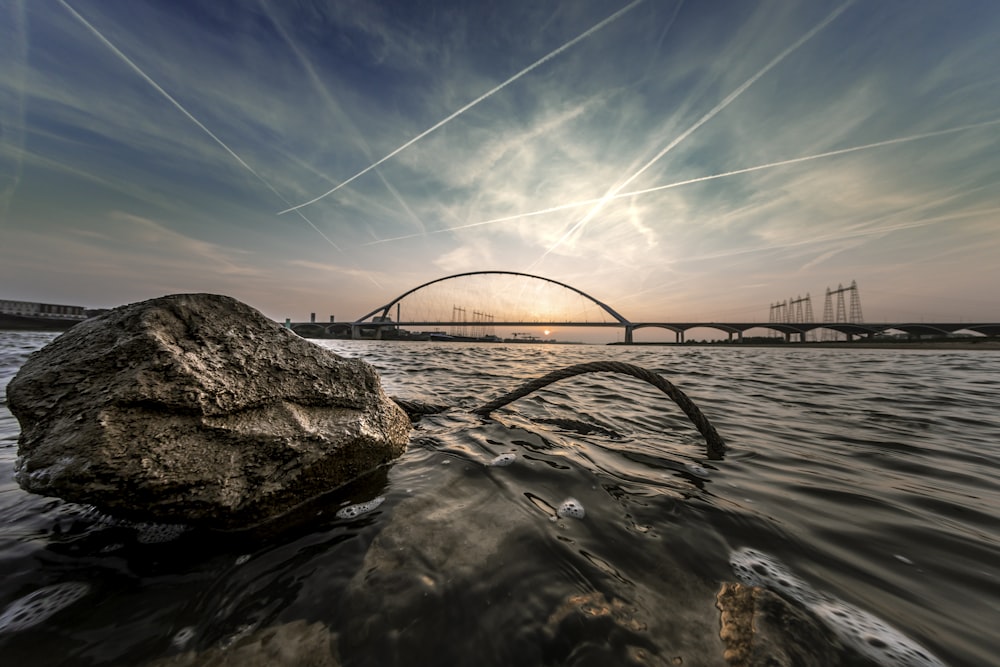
364, 113, 1000, 245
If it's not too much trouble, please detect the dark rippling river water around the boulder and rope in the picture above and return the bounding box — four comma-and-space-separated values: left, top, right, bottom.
0, 333, 1000, 667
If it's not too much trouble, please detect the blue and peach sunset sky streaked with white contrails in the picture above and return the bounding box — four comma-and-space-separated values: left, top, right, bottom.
0, 0, 1000, 342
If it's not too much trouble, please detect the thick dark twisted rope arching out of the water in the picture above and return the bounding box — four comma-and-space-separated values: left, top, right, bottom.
394, 361, 726, 460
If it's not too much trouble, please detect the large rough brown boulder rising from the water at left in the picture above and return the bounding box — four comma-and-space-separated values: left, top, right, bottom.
7, 294, 410, 529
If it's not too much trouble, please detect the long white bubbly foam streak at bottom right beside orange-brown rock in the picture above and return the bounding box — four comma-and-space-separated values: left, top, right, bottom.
729, 549, 944, 667
